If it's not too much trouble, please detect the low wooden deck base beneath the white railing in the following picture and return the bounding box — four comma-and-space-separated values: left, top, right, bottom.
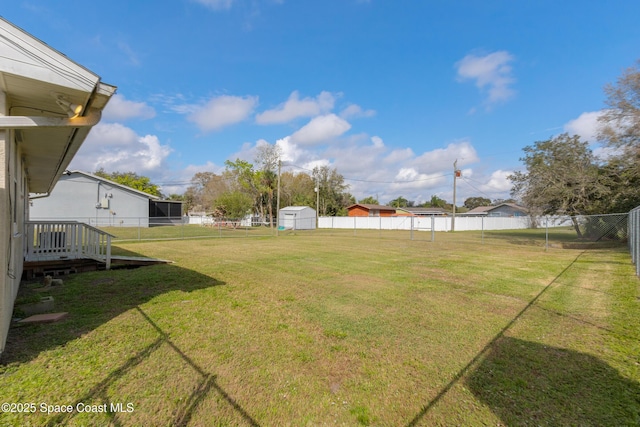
22, 255, 173, 280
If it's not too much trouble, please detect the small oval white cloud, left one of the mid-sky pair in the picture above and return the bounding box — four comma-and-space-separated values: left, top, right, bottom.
188, 95, 258, 132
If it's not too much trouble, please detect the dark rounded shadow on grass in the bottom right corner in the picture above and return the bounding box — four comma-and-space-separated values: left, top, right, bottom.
466, 337, 640, 426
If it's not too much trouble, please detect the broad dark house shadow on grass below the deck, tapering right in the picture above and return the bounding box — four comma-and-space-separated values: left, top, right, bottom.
0, 252, 219, 365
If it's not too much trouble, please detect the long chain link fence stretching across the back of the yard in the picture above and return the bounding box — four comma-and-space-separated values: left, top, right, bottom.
30, 214, 640, 251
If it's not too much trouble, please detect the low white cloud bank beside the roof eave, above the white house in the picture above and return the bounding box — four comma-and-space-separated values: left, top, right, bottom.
71, 123, 172, 176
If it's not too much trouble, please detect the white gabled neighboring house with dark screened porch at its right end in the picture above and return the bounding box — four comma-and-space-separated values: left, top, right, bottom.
30, 171, 182, 227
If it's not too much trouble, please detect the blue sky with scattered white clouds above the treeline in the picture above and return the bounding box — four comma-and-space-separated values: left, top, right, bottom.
0, 0, 640, 206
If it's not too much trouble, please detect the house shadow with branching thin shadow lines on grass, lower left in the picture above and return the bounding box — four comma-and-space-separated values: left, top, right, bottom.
0, 248, 258, 426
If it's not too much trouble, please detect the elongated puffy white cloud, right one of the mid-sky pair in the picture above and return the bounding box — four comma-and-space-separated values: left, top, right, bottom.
256, 91, 335, 125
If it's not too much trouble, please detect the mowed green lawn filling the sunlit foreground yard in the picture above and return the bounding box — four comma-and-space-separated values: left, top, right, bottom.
0, 232, 640, 426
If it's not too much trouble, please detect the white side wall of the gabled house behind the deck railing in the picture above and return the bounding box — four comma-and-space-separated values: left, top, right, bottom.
30, 173, 154, 227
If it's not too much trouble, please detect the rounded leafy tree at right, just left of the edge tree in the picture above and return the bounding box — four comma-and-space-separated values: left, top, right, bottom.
509, 133, 608, 236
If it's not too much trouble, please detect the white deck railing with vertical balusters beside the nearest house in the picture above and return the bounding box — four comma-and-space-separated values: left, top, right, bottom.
25, 221, 113, 270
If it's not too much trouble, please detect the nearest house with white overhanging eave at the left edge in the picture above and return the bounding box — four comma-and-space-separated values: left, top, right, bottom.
0, 18, 116, 353
